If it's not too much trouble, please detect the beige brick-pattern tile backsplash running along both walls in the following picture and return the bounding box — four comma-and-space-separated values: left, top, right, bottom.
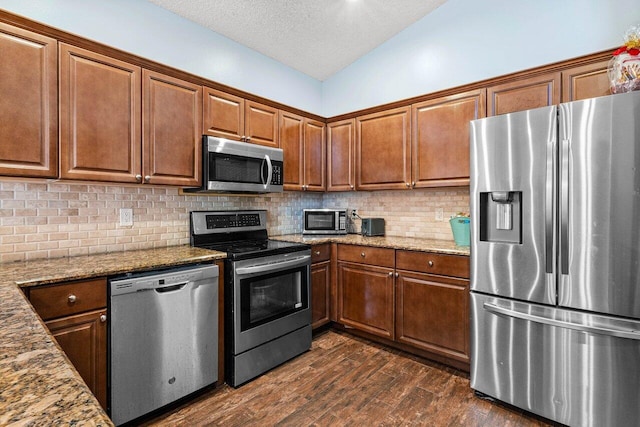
0, 180, 469, 263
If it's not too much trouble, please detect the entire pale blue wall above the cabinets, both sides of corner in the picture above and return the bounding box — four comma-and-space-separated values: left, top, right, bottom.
0, 0, 640, 117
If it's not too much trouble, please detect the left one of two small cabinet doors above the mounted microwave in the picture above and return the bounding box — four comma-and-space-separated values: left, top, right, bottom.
202, 87, 244, 141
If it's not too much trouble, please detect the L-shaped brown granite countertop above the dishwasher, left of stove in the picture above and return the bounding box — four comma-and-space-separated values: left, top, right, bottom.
0, 246, 226, 426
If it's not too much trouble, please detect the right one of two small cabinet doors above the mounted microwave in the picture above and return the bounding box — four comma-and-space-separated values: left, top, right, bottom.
244, 101, 280, 148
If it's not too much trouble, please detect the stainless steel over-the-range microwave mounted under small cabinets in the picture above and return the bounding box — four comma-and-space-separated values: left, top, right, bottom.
184, 135, 284, 193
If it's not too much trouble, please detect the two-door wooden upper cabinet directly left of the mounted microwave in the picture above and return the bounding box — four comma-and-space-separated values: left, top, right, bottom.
60, 43, 202, 186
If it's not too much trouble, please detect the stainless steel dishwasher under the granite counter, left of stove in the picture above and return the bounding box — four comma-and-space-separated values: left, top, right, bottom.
109, 265, 219, 425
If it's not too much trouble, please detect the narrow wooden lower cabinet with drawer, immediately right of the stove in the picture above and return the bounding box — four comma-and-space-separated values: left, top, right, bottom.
311, 243, 331, 329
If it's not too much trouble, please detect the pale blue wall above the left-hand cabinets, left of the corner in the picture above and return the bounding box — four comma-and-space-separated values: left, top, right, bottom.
0, 0, 322, 114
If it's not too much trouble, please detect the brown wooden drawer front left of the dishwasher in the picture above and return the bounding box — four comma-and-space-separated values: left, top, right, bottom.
29, 277, 107, 320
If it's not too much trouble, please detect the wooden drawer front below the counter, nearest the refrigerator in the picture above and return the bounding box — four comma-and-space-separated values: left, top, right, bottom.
396, 251, 469, 279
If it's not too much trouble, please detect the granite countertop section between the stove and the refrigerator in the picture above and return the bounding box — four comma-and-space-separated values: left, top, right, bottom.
269, 234, 470, 256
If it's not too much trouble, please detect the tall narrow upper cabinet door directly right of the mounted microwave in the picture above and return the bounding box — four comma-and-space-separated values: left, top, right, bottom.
280, 111, 304, 191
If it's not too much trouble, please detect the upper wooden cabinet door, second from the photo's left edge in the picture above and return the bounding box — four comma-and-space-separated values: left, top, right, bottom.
60, 43, 141, 182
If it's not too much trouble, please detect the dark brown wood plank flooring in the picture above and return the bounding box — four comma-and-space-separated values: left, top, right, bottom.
144, 330, 550, 426
